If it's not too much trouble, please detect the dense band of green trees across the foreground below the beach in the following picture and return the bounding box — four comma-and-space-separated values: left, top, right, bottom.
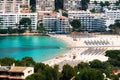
0, 50, 120, 80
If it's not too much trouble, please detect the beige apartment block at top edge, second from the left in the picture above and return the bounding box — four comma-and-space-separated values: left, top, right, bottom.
36, 0, 55, 11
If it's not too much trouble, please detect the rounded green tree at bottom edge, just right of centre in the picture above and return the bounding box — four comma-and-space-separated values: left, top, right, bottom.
61, 64, 75, 80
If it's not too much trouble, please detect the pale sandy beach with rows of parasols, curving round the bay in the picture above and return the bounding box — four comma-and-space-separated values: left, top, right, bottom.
43, 35, 120, 67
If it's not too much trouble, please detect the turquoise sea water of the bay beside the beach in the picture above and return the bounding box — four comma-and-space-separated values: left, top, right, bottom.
0, 36, 67, 62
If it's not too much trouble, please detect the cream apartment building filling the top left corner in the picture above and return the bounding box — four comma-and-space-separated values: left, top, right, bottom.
0, 0, 30, 13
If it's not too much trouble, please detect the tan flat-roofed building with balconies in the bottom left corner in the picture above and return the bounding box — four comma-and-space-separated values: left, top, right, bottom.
0, 66, 34, 80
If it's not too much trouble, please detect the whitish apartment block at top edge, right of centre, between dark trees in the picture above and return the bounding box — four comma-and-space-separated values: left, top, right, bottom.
63, 0, 81, 10
